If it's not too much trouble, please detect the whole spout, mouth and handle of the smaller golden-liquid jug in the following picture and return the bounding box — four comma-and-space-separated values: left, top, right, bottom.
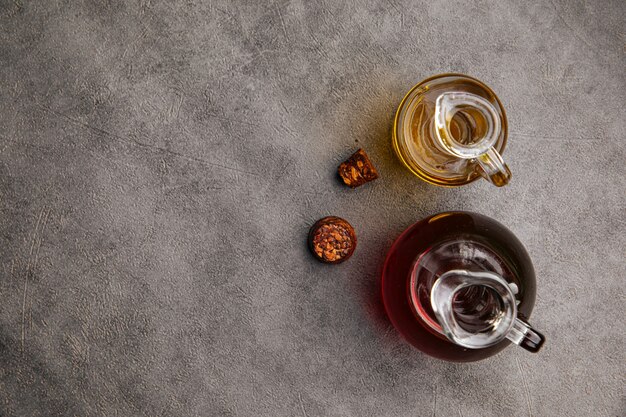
435, 92, 511, 187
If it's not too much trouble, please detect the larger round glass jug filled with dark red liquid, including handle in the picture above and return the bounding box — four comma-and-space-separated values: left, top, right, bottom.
382, 212, 545, 362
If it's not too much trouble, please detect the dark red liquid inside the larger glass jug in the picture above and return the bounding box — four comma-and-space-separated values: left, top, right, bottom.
382, 212, 535, 362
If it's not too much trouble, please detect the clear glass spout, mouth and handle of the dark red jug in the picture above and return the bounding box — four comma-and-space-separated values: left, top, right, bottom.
430, 269, 545, 352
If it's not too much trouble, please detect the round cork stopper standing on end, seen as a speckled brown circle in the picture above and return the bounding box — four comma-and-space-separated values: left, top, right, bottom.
309, 216, 356, 264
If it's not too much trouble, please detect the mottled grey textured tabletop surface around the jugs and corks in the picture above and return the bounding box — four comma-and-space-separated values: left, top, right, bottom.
0, 0, 626, 417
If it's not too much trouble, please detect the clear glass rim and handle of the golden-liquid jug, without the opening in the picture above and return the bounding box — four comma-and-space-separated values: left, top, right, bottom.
435, 91, 511, 187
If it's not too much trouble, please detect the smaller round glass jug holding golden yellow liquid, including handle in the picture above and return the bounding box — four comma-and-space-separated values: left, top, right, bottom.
393, 74, 511, 187
